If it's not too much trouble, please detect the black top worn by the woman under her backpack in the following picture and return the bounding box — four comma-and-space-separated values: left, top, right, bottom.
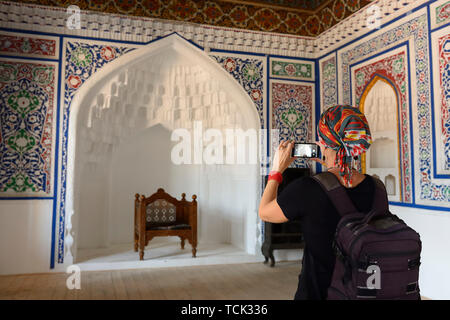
277, 174, 375, 300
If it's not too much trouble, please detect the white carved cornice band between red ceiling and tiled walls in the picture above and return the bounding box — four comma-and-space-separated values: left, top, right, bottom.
0, 0, 427, 59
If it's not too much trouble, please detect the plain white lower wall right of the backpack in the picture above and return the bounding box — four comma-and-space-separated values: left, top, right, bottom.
390, 206, 450, 299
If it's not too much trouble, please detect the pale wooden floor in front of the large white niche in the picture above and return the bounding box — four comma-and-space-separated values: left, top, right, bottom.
0, 261, 301, 300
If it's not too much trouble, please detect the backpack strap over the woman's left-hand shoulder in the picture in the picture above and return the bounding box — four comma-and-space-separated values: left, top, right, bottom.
312, 172, 358, 216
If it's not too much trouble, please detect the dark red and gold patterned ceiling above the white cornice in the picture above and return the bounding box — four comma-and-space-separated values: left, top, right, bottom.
6, 0, 371, 37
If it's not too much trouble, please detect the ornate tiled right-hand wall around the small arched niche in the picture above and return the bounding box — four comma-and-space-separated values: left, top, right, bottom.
319, 1, 450, 207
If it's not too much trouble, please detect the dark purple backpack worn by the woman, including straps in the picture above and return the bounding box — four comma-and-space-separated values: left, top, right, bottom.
313, 172, 422, 300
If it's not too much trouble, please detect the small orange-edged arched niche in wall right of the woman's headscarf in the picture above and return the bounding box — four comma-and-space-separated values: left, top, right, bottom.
360, 75, 401, 201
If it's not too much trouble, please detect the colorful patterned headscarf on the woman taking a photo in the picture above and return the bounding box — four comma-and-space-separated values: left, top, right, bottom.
317, 105, 372, 186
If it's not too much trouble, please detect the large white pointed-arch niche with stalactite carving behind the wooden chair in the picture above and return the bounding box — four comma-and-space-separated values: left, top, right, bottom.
65, 34, 261, 264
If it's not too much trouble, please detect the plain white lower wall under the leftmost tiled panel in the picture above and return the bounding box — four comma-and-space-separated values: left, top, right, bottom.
0, 200, 53, 274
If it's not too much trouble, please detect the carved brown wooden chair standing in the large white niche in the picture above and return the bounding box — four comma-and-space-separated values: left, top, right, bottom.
134, 188, 197, 260
